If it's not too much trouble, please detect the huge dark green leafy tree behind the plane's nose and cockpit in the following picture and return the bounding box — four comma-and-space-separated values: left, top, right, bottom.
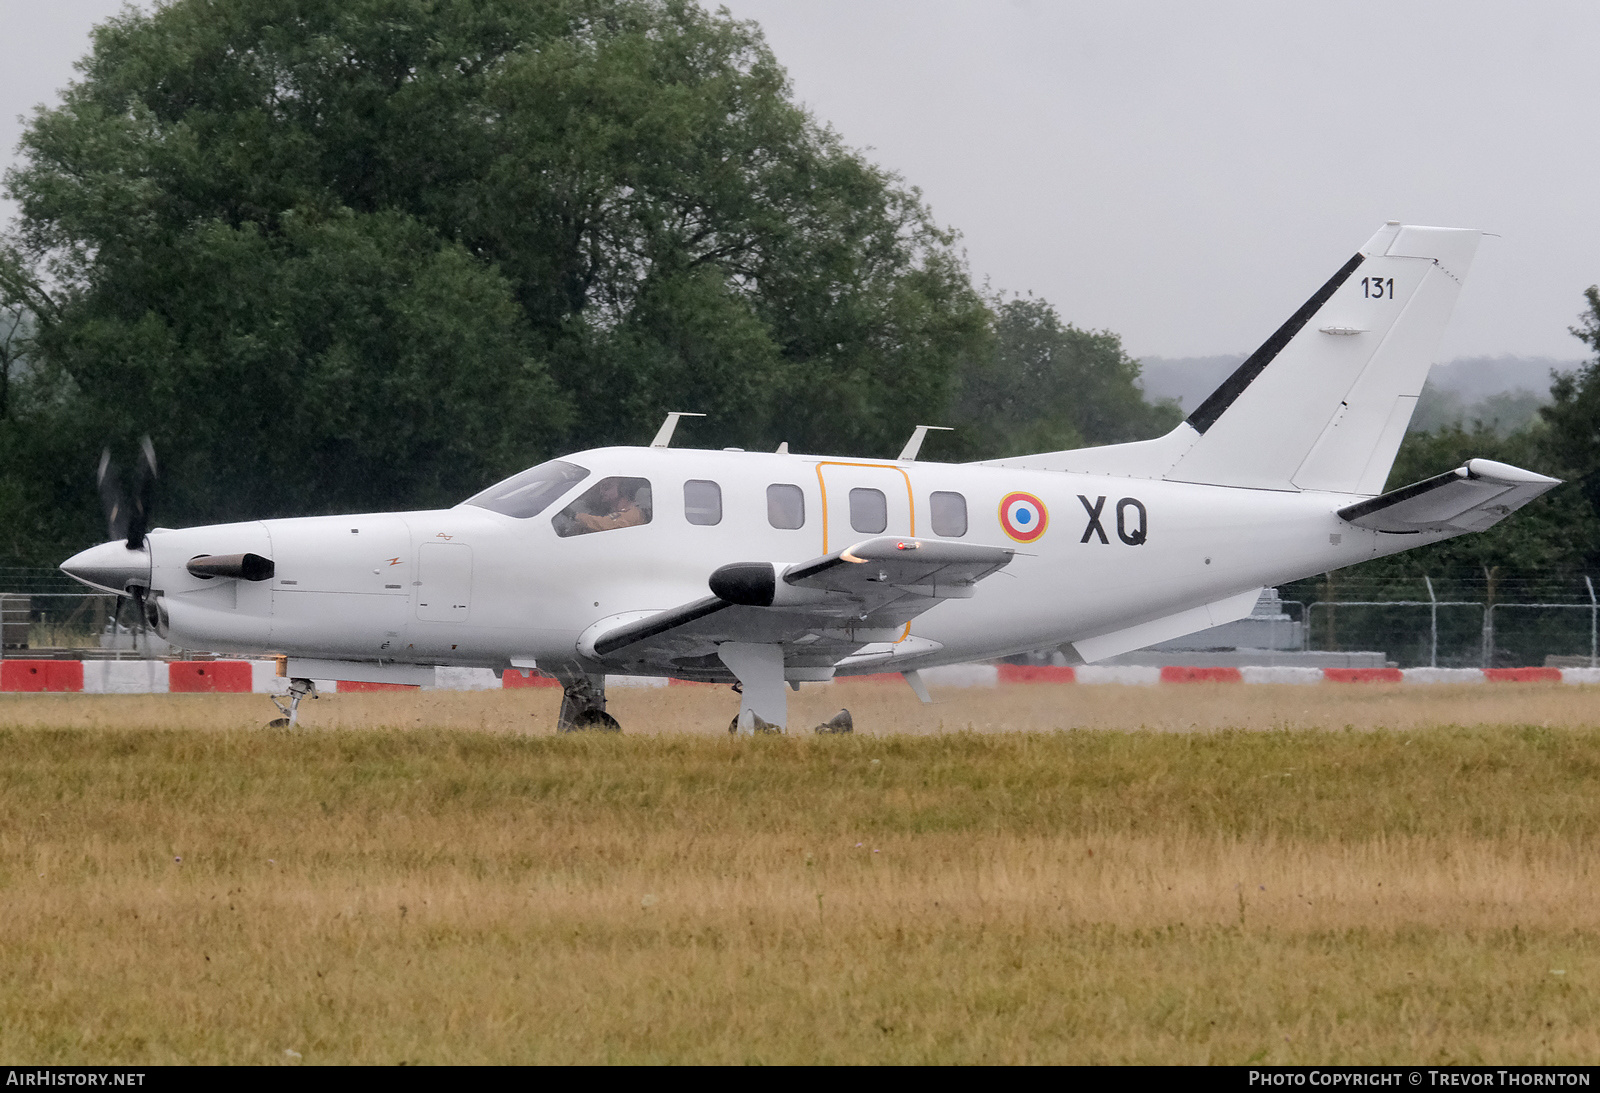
8, 0, 986, 534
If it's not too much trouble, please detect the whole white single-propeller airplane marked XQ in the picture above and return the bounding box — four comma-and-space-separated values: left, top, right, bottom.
61, 222, 1558, 733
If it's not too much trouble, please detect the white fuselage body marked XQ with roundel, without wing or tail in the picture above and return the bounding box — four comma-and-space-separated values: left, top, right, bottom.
116, 448, 1434, 674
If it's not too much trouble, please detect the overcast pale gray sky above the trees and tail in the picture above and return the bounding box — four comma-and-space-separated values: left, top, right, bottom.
0, 0, 1600, 360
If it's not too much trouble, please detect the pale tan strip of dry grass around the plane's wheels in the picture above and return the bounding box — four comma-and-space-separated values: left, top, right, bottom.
0, 682, 1600, 736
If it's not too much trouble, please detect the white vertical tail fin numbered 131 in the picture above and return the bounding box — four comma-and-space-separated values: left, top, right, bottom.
995, 224, 1482, 494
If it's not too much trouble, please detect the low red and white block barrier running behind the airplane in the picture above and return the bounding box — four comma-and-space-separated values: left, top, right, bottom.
9, 659, 1600, 695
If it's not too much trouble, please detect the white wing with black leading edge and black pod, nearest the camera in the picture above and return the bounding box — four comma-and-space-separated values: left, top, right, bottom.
579, 538, 1016, 680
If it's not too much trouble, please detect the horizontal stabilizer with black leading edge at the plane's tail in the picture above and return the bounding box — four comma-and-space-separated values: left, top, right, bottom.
1339, 459, 1562, 534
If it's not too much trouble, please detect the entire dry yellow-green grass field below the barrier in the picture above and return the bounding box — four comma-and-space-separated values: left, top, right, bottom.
0, 683, 1600, 1063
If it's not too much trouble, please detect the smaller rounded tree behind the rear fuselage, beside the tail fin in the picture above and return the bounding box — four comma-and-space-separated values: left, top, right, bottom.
955, 296, 1182, 458
